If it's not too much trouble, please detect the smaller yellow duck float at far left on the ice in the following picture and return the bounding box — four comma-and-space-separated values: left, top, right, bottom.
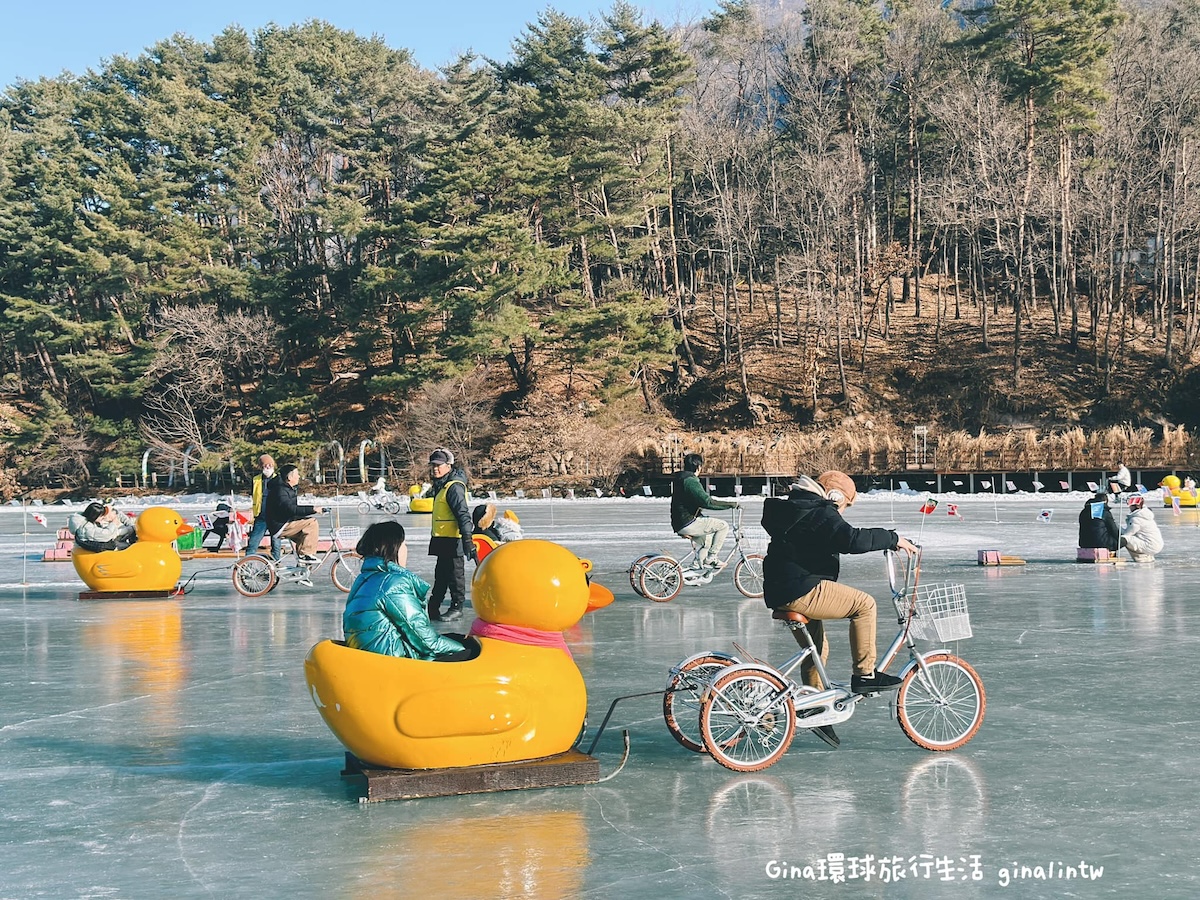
71, 506, 192, 593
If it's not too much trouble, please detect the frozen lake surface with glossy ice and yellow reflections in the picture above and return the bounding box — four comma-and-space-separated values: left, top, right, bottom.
0, 494, 1200, 900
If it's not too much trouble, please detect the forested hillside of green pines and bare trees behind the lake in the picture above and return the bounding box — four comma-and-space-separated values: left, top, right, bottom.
0, 0, 1200, 496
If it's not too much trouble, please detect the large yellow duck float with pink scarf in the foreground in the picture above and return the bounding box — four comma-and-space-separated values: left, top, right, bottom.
305, 540, 611, 769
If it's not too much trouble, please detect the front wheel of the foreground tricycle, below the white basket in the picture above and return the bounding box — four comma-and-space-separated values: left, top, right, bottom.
896, 653, 988, 750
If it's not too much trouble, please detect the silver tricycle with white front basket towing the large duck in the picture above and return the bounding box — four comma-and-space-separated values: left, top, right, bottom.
664, 550, 988, 772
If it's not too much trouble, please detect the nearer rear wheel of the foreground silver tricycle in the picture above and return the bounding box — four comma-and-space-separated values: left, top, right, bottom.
700, 668, 796, 772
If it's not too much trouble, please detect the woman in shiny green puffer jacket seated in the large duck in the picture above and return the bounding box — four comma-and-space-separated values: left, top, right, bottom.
342, 522, 476, 661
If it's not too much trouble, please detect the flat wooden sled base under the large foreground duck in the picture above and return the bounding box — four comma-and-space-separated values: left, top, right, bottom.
342, 750, 600, 803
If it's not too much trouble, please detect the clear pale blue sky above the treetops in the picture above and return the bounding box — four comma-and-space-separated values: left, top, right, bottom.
0, 0, 716, 90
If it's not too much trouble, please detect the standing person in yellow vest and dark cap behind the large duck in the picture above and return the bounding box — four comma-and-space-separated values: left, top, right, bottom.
428, 448, 479, 622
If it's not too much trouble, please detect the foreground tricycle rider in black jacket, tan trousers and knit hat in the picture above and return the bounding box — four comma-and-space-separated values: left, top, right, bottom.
762, 472, 917, 743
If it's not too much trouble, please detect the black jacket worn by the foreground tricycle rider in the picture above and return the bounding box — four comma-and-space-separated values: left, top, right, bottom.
762, 488, 899, 610
